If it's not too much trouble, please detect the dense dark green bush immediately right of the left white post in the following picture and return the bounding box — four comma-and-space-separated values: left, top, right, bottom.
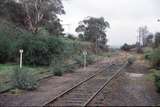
19, 36, 63, 65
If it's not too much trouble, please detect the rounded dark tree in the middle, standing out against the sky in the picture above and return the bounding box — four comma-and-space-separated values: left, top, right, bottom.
76, 17, 110, 48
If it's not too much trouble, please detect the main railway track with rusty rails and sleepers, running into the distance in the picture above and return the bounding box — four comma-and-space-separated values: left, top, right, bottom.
43, 63, 127, 106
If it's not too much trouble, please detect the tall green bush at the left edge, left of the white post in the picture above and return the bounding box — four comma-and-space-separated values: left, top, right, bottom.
0, 22, 20, 63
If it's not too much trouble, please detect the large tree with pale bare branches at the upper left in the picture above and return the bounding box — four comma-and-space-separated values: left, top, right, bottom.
1, 0, 65, 33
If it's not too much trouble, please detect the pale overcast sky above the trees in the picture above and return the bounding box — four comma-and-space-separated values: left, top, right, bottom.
61, 0, 160, 46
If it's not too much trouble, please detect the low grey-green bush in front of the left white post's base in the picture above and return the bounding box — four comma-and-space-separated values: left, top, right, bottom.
12, 68, 38, 91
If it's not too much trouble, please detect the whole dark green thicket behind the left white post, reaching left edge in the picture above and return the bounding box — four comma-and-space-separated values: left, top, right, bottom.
0, 21, 64, 65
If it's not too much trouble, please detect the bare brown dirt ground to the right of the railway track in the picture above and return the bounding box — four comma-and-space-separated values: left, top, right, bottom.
91, 61, 160, 106
